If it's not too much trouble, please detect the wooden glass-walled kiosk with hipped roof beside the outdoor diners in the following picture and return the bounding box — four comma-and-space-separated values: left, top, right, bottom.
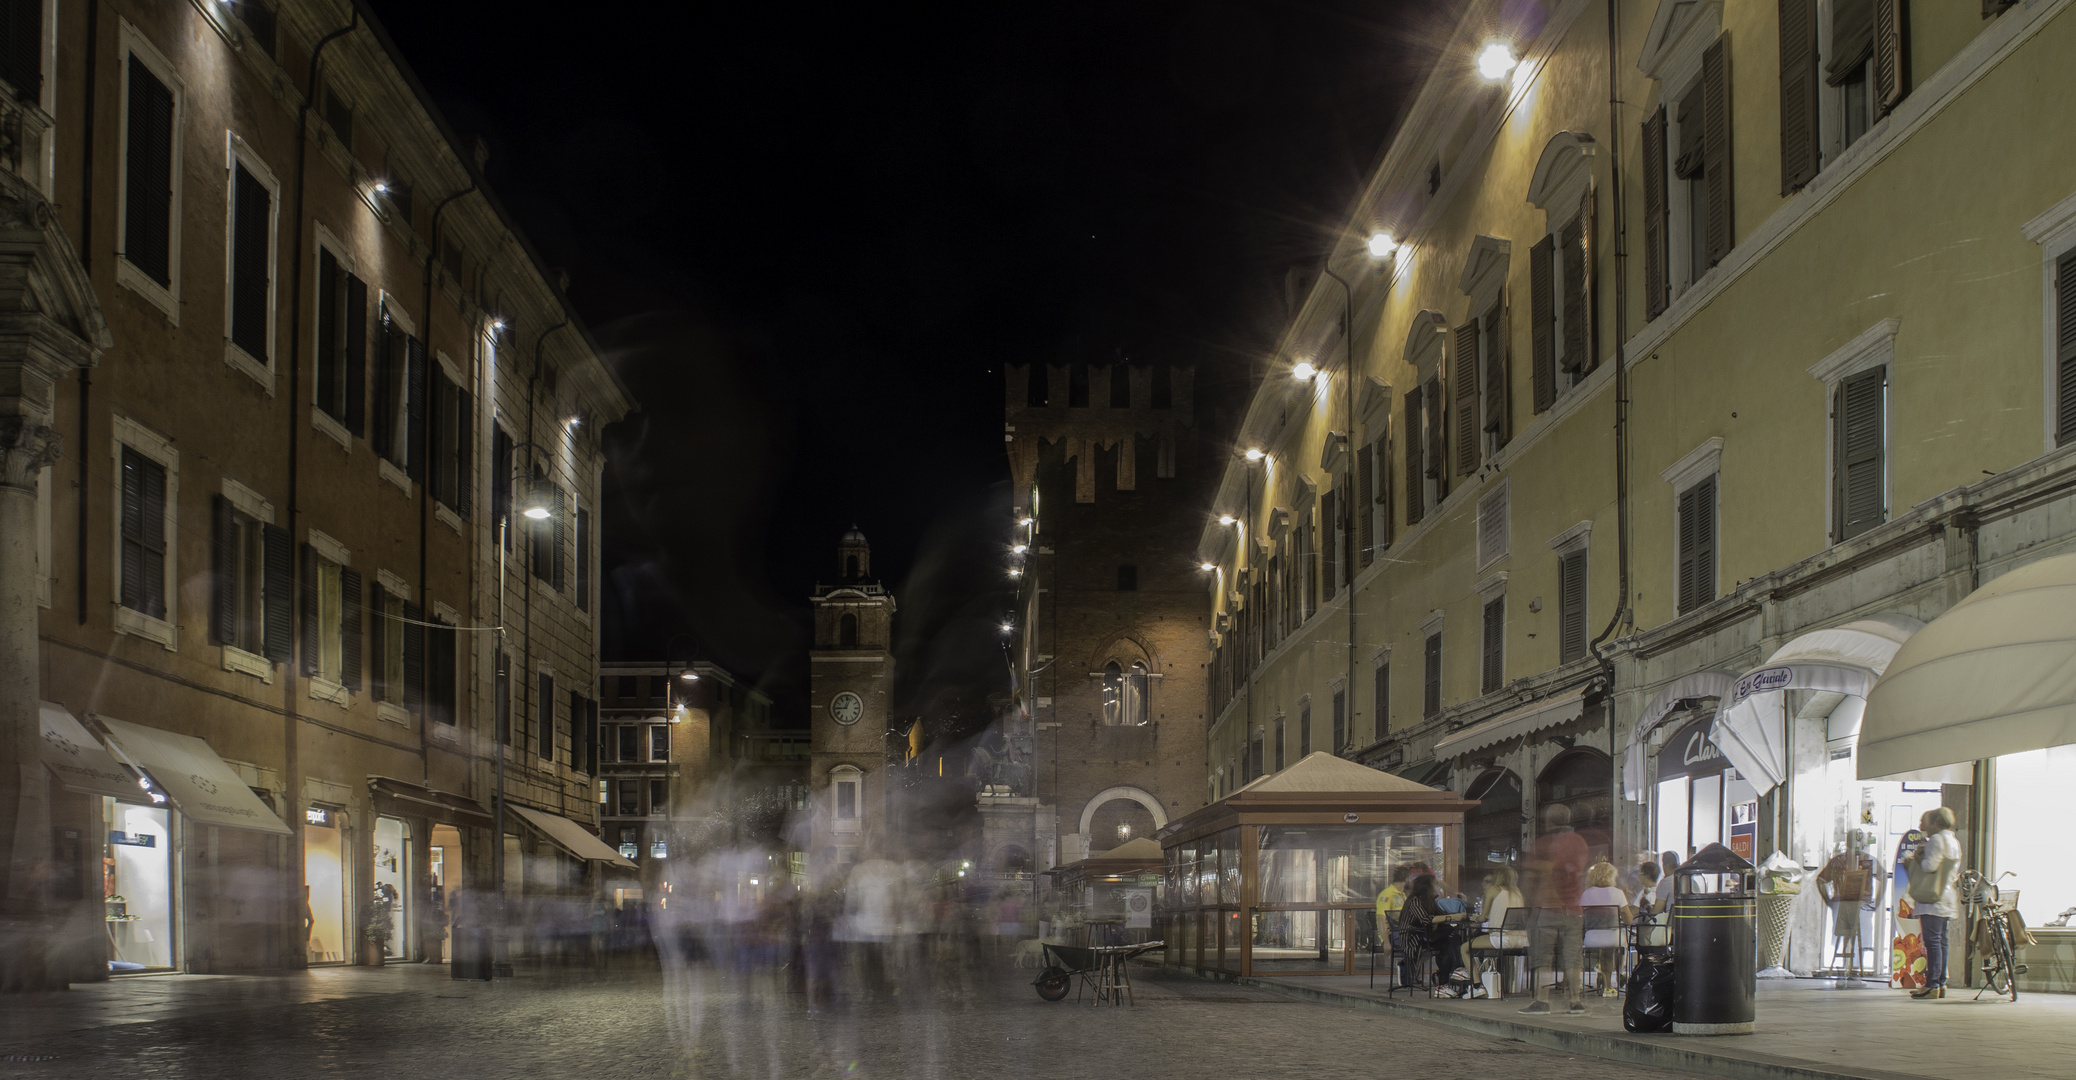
1158, 752, 1474, 976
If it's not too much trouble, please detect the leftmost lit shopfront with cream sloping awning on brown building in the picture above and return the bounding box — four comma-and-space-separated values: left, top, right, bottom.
86, 706, 289, 974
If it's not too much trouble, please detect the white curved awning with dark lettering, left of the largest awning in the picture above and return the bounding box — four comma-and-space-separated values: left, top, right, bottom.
1711, 613, 1924, 795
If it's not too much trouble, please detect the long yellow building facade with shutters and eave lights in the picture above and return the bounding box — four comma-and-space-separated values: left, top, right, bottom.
1198, 0, 2076, 984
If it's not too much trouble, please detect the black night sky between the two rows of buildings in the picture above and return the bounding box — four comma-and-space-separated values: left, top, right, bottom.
374, 0, 1453, 723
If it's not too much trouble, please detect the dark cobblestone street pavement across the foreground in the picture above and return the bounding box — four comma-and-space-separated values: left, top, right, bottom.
0, 966, 1694, 1080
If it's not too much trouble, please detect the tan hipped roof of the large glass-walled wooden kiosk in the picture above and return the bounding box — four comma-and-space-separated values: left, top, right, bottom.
1154, 750, 1478, 847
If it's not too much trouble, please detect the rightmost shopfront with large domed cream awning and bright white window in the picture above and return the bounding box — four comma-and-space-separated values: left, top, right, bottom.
1856, 555, 2076, 991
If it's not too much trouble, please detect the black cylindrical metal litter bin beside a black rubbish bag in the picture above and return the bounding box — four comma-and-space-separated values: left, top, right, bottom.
1673, 843, 1758, 1034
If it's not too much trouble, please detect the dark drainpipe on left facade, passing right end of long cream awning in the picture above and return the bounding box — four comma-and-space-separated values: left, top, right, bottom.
280, 6, 361, 968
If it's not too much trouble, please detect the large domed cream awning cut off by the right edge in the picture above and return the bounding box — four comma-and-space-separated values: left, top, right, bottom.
1860, 555, 2076, 779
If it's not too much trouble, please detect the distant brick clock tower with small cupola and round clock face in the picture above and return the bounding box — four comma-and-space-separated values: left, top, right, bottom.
808, 525, 895, 881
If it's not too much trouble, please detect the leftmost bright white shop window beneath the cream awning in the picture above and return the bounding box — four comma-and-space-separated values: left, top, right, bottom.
102, 800, 179, 972
